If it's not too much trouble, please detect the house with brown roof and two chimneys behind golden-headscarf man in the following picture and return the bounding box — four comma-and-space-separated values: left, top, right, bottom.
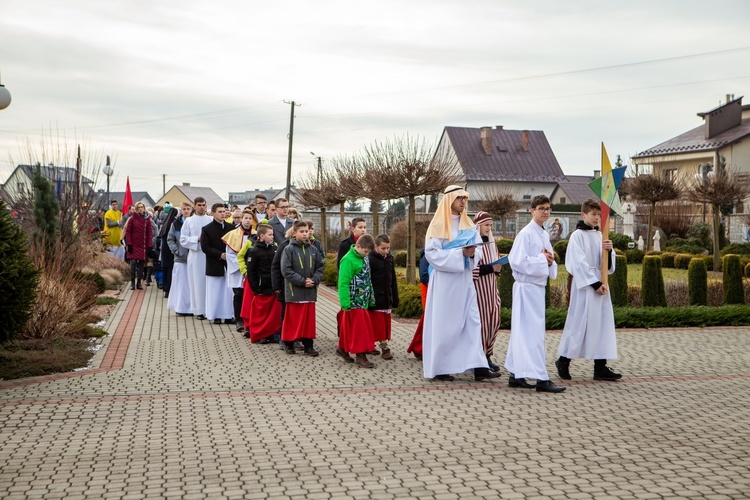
438, 126, 566, 210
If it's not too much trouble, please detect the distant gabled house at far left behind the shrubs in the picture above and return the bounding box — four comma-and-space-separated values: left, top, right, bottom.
2, 165, 94, 203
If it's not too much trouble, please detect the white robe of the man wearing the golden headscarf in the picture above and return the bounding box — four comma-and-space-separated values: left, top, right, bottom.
422, 216, 488, 378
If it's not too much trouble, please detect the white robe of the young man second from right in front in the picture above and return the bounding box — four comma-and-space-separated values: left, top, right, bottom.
505, 221, 557, 380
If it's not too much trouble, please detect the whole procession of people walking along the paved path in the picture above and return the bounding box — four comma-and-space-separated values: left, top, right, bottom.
104, 185, 621, 393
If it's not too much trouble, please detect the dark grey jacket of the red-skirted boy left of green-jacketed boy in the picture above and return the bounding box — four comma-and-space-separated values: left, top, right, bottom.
281, 239, 323, 302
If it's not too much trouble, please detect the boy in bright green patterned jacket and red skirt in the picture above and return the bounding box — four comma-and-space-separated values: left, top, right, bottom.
336, 234, 375, 368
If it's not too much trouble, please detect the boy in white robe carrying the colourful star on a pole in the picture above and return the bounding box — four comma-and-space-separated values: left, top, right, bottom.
555, 199, 622, 381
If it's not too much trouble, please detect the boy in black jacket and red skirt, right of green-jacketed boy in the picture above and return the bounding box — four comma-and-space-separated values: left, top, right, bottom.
368, 234, 398, 359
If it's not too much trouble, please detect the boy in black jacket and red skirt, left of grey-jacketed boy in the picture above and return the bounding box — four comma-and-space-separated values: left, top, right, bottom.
245, 224, 281, 344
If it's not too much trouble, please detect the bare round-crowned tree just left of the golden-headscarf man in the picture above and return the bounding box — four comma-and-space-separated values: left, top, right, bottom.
363, 135, 461, 283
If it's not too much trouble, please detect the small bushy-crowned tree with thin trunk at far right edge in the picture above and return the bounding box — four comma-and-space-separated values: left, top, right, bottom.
687, 156, 750, 270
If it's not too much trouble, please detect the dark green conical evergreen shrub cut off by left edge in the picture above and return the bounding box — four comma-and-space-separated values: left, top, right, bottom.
0, 200, 40, 343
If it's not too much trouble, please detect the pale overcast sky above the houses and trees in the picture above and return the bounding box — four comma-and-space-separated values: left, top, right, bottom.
0, 0, 750, 199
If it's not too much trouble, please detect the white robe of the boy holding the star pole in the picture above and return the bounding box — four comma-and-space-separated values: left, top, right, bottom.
557, 229, 617, 360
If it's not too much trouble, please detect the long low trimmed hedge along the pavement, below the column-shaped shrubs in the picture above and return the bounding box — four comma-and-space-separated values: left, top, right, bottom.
500, 305, 750, 330
